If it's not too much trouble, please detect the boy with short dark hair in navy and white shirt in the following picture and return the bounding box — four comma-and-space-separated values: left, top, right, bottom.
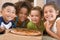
0, 2, 16, 32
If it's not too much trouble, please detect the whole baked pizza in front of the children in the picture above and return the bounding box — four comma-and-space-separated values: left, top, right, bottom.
10, 29, 41, 36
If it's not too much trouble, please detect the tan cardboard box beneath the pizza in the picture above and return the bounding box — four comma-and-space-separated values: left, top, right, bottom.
0, 30, 42, 40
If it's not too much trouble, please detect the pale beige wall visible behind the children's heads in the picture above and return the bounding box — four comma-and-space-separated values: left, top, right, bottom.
0, 0, 45, 9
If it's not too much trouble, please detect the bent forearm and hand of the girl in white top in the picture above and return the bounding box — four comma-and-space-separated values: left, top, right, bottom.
44, 21, 60, 40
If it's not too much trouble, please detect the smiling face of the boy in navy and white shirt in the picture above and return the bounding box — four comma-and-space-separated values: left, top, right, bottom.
2, 6, 16, 21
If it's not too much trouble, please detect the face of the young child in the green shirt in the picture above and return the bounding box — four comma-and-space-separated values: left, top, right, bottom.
30, 10, 40, 24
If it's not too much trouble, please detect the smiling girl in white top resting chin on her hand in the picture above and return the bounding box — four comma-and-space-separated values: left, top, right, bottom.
43, 3, 60, 40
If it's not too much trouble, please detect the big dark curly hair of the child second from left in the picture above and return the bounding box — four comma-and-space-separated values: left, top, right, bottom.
15, 1, 32, 14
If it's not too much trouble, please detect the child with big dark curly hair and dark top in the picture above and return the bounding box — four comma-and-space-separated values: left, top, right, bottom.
14, 1, 32, 28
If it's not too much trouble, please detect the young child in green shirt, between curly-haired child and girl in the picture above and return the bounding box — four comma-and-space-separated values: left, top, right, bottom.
27, 6, 44, 32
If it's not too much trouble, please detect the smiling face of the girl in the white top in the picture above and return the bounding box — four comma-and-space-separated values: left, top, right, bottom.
44, 5, 58, 21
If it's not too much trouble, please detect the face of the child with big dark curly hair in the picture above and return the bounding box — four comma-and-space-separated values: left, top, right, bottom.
18, 7, 28, 22
